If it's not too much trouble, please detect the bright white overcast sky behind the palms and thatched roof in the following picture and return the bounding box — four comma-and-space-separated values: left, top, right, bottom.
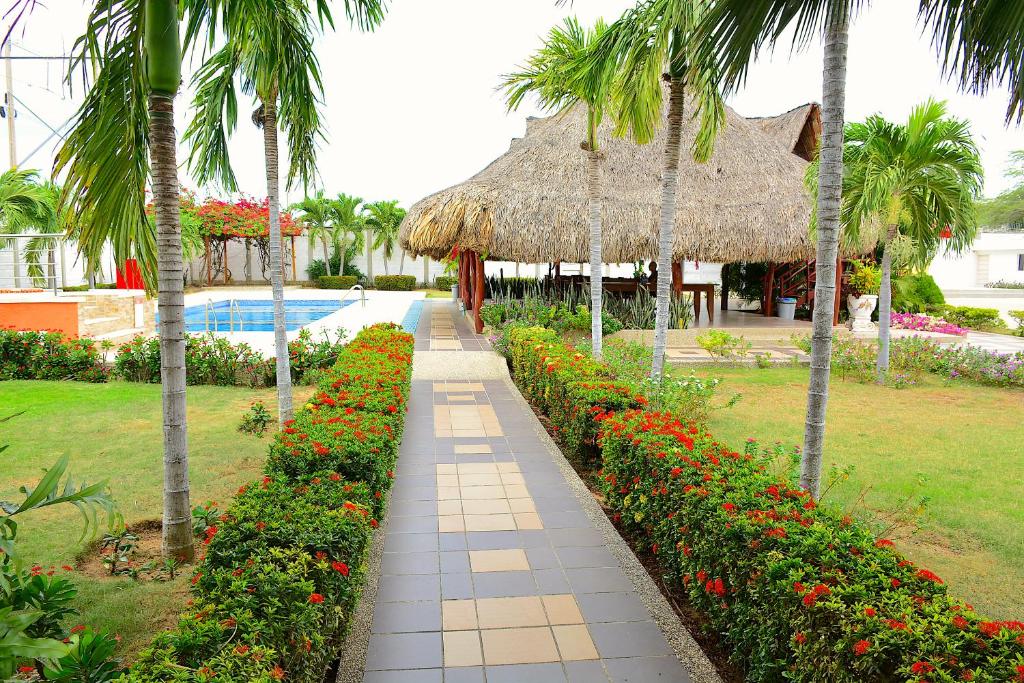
8, 0, 1024, 207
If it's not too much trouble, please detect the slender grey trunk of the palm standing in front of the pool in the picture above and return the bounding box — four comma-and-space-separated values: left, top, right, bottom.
263, 93, 292, 424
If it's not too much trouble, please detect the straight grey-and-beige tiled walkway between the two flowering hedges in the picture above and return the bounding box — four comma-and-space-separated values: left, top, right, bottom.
339, 302, 717, 683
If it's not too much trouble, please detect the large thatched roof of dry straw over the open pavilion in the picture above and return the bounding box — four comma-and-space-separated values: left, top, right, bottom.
400, 96, 814, 263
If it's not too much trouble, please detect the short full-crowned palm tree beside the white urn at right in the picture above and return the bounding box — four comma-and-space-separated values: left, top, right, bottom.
827, 99, 982, 382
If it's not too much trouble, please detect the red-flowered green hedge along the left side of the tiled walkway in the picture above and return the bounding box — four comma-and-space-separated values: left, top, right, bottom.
124, 325, 413, 683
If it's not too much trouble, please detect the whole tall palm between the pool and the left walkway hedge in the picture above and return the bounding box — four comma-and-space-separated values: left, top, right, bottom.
185, 0, 384, 424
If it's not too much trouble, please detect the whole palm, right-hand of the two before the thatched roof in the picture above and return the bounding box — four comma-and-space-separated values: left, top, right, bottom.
592, 0, 725, 379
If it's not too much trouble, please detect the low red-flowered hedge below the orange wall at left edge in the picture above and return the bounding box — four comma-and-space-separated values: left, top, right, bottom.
0, 329, 108, 382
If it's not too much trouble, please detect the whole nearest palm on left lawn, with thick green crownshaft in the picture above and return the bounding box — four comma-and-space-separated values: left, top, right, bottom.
54, 0, 194, 560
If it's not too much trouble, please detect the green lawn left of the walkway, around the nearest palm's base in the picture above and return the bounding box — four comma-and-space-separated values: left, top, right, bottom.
0, 382, 309, 653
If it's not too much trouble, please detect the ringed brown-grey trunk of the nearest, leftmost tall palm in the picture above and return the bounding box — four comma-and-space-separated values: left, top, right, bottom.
150, 92, 195, 561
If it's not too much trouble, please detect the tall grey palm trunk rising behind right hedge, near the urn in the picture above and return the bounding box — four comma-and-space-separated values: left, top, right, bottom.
800, 10, 850, 498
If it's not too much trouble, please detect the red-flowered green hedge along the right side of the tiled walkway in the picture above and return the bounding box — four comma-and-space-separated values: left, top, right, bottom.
511, 329, 1024, 681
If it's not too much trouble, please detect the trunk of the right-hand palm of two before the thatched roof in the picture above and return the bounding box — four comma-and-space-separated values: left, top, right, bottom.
650, 76, 683, 379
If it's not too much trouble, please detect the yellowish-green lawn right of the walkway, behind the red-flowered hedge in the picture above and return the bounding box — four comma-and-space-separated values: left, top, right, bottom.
697, 367, 1024, 620
